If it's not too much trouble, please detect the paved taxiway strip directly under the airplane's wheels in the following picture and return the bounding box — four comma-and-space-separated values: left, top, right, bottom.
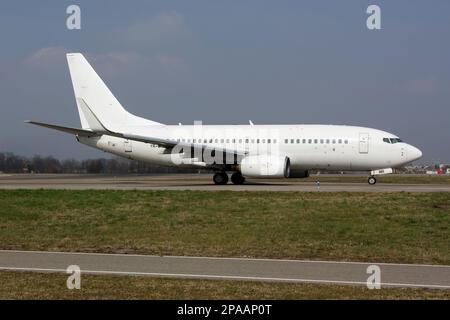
0, 174, 450, 192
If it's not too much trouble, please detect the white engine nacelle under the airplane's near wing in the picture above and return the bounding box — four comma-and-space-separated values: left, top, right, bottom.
240, 154, 291, 178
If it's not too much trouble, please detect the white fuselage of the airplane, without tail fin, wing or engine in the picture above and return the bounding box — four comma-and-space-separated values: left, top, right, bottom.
79, 125, 421, 170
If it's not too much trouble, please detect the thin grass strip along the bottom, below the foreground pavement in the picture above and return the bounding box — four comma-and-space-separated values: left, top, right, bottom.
0, 272, 450, 299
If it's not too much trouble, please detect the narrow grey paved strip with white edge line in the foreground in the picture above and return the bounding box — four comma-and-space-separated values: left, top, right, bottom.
0, 251, 450, 289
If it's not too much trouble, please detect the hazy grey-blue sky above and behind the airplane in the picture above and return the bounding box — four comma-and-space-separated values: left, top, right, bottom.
0, 0, 450, 163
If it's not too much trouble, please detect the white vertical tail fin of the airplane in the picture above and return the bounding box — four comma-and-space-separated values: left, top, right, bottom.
67, 53, 161, 131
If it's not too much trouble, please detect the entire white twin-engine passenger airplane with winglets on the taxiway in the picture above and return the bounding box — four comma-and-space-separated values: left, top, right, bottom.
27, 53, 422, 185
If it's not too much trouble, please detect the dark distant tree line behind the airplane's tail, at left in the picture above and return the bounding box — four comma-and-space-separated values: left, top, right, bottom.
0, 152, 198, 174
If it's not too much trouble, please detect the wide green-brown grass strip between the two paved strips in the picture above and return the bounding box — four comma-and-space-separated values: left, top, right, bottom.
0, 190, 450, 265
